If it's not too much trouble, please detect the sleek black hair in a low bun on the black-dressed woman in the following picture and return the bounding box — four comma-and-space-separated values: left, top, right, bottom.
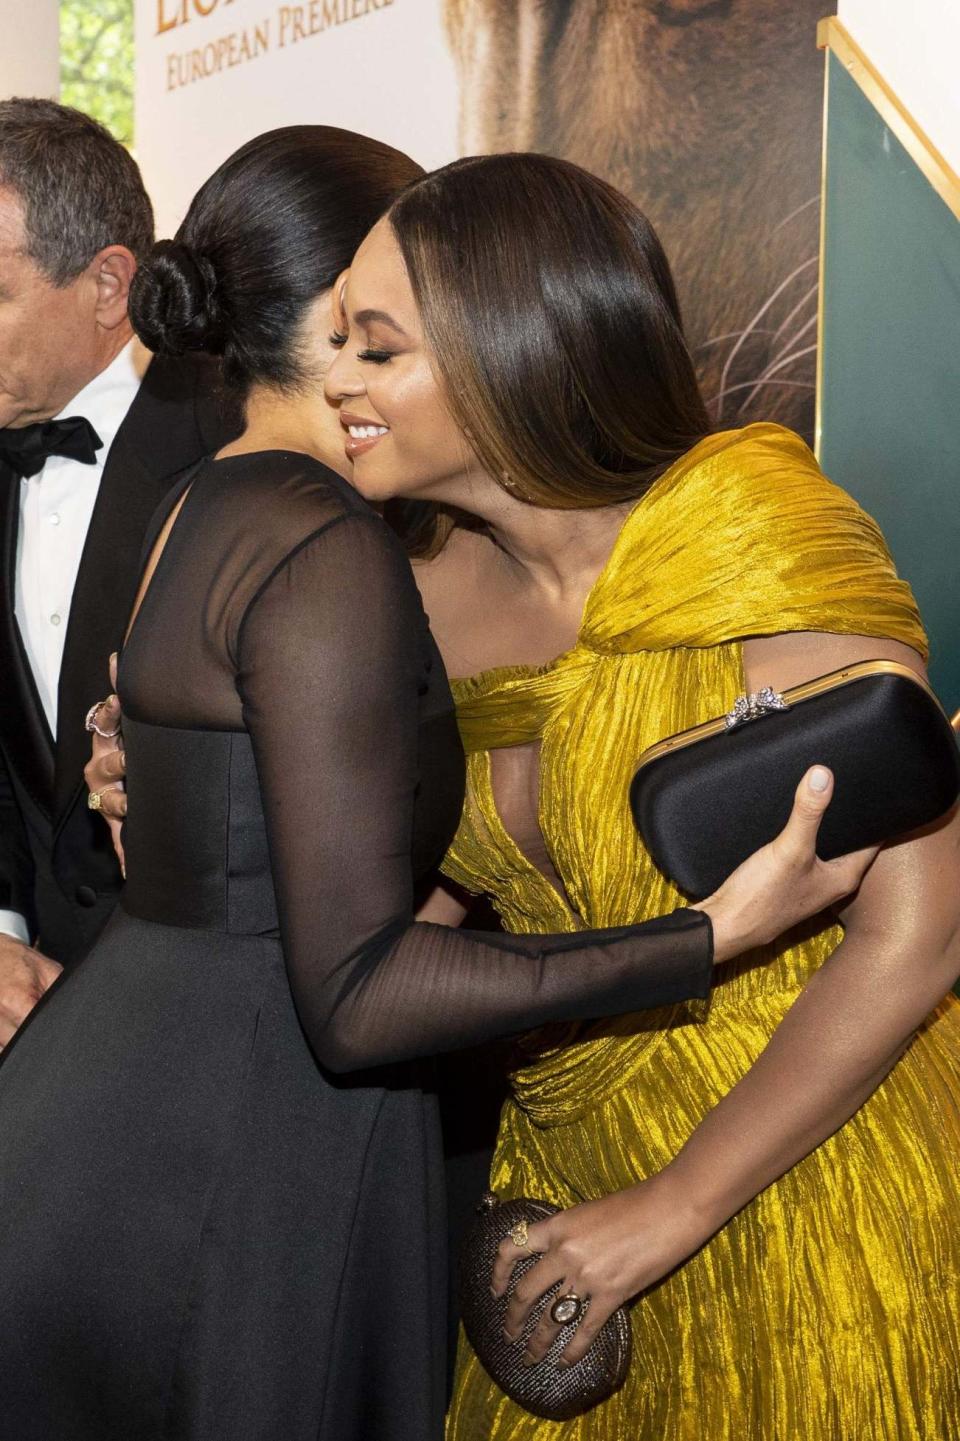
130, 125, 424, 389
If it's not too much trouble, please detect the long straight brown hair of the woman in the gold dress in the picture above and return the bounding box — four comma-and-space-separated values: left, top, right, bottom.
389, 154, 711, 544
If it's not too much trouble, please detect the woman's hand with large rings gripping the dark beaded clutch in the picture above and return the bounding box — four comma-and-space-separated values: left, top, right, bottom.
493, 1173, 706, 1366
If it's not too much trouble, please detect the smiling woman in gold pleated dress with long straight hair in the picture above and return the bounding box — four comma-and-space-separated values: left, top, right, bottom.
327, 156, 960, 1441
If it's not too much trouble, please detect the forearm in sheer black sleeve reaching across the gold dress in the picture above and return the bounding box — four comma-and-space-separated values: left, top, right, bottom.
299, 909, 712, 1071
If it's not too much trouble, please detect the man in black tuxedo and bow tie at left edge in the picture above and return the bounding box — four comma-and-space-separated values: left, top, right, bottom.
0, 99, 239, 1045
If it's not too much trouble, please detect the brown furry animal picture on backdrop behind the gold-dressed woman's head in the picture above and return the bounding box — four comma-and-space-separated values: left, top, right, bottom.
444, 0, 825, 440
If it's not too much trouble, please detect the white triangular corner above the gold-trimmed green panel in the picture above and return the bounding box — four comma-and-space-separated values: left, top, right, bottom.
837, 0, 960, 174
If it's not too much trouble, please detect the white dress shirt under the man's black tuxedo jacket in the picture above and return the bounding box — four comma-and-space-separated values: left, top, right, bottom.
0, 340, 141, 941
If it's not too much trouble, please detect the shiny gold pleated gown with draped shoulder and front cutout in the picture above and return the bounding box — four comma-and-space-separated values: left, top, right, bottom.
444, 425, 960, 1441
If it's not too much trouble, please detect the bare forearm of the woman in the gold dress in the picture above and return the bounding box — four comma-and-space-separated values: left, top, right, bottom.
665, 925, 960, 1238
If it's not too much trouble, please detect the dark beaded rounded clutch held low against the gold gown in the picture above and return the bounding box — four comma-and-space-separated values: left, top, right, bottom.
460, 1192, 631, 1421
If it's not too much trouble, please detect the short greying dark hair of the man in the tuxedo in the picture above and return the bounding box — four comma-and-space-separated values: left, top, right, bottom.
0, 99, 153, 285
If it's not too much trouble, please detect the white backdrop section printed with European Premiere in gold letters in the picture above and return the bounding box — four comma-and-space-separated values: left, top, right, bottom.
135, 0, 457, 236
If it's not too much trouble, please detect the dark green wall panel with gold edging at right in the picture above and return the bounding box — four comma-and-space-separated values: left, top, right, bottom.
820, 55, 960, 710
